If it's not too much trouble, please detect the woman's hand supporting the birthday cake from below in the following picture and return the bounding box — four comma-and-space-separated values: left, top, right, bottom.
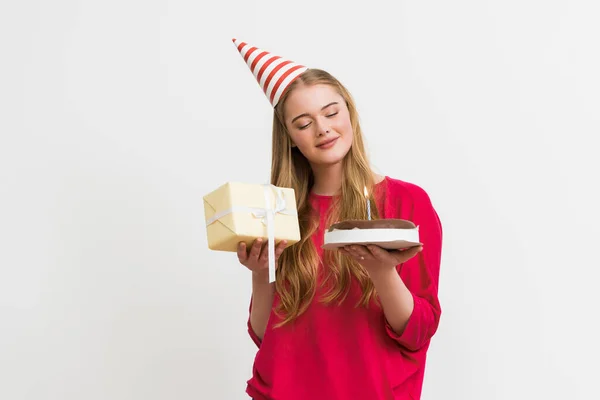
338, 245, 423, 274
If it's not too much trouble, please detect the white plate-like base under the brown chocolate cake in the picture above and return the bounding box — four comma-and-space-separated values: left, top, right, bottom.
322, 227, 421, 250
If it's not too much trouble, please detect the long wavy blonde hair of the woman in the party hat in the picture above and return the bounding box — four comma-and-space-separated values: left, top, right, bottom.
271, 69, 378, 326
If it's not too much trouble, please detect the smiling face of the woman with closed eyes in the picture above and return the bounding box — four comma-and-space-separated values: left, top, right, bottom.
284, 85, 352, 165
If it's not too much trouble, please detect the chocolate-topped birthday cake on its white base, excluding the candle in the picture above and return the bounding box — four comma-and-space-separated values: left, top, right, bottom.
322, 219, 421, 250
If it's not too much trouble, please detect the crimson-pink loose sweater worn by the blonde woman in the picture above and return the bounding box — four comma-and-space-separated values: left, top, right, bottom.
246, 177, 442, 400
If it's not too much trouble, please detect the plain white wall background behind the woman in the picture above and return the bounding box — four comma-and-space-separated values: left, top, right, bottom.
0, 0, 600, 400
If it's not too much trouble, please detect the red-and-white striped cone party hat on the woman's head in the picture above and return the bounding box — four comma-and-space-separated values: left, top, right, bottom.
233, 38, 308, 107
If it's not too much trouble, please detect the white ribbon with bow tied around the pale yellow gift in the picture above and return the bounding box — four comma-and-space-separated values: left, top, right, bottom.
206, 184, 297, 283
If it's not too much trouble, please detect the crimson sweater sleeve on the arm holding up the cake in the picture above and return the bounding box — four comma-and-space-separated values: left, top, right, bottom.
385, 186, 442, 351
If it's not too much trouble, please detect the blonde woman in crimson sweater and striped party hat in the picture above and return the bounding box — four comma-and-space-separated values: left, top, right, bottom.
234, 39, 442, 400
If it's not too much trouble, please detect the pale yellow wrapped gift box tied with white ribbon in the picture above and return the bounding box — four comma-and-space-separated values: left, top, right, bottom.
203, 182, 300, 278
